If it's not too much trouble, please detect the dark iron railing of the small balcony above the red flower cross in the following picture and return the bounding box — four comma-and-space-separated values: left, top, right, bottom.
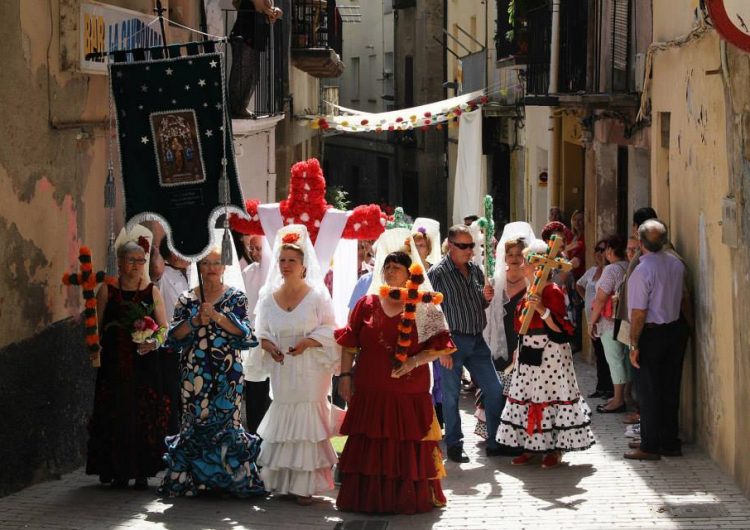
292, 0, 343, 56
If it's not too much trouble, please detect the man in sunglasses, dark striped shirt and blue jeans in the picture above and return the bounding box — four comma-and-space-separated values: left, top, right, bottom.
427, 225, 505, 463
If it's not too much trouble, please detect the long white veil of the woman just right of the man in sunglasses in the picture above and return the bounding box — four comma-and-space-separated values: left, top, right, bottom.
484, 221, 537, 359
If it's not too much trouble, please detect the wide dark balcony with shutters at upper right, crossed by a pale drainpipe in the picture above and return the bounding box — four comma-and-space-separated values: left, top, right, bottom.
525, 0, 637, 107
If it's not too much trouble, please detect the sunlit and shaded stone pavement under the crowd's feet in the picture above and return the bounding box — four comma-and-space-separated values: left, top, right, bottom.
0, 363, 750, 530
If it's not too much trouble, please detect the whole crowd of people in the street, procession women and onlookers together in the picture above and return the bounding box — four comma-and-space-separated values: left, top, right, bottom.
86, 201, 692, 514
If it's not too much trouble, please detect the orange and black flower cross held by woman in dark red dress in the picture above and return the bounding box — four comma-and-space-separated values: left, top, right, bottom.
380, 263, 443, 369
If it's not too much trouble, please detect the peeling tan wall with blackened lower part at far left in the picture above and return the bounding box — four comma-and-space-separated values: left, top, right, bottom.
0, 0, 197, 495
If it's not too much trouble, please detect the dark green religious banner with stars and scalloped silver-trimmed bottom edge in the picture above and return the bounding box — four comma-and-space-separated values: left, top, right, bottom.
110, 48, 245, 259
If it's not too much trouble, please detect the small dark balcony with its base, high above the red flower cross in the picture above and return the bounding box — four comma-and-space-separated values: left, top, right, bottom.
291, 0, 344, 78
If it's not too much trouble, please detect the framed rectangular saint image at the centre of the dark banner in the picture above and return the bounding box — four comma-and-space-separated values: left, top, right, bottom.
149, 110, 206, 186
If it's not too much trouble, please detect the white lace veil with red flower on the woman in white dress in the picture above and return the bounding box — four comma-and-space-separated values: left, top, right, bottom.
258, 225, 331, 304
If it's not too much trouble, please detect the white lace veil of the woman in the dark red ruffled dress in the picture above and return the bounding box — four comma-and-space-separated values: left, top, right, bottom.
367, 228, 448, 342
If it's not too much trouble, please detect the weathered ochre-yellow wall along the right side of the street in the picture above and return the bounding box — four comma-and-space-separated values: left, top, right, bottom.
652, 26, 747, 473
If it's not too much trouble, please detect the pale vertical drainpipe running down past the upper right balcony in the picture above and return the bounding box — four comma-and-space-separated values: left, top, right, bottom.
544, 0, 562, 217
